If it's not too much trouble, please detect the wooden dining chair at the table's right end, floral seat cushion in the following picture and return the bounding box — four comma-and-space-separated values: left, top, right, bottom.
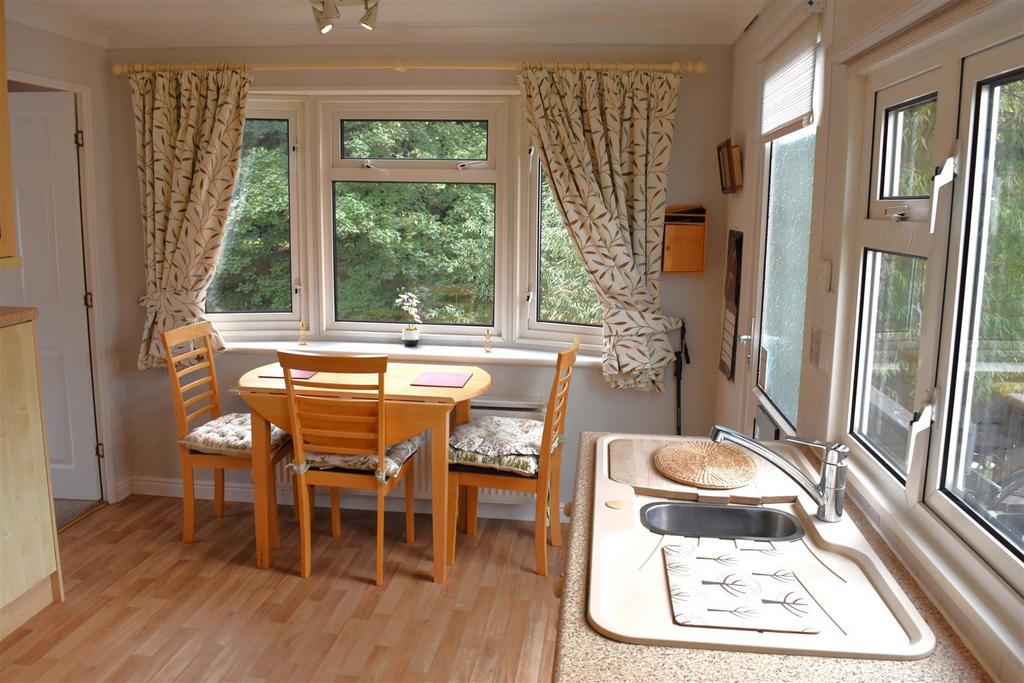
446, 342, 580, 577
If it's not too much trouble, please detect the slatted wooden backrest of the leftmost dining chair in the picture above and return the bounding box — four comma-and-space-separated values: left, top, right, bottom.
161, 322, 220, 439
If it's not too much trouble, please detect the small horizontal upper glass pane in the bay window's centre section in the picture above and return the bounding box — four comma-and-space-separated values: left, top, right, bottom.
341, 120, 487, 161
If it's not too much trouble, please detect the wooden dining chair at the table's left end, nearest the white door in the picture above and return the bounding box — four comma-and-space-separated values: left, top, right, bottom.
161, 322, 291, 544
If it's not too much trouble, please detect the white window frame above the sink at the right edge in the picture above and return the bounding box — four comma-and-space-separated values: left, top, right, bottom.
834, 2, 1024, 614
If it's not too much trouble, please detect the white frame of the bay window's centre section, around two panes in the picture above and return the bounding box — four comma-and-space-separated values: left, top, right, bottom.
316, 94, 514, 344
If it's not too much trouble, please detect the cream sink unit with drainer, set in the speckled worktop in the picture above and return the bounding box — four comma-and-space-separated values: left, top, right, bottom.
587, 434, 935, 659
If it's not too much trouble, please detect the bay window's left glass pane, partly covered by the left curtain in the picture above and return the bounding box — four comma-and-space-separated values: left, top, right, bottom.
206, 119, 292, 313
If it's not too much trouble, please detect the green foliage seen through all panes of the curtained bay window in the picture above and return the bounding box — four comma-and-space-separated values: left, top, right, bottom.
206, 114, 601, 326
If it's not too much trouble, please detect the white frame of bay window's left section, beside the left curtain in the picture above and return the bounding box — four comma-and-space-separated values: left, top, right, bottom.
204, 94, 308, 340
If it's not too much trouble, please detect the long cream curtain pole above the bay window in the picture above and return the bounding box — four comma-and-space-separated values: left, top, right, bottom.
111, 59, 708, 76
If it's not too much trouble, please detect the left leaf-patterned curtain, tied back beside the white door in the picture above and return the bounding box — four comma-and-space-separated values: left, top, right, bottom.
129, 69, 251, 370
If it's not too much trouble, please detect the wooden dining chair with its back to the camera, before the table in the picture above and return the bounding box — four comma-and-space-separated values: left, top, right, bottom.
278, 351, 424, 586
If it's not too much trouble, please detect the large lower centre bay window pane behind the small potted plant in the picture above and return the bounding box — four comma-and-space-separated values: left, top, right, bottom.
334, 182, 495, 326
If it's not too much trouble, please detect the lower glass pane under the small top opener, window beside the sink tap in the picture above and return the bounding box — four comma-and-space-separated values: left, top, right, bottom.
854, 250, 927, 476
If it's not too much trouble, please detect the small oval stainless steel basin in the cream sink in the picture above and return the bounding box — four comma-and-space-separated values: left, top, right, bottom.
640, 503, 804, 541
